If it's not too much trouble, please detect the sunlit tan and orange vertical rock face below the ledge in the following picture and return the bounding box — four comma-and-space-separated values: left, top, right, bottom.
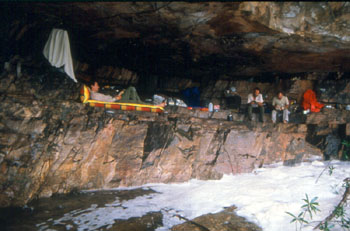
0, 72, 321, 206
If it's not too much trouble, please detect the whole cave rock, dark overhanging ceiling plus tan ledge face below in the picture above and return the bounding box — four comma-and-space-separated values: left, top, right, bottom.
0, 2, 350, 209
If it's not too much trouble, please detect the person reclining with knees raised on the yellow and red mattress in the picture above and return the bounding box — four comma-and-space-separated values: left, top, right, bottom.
90, 81, 165, 107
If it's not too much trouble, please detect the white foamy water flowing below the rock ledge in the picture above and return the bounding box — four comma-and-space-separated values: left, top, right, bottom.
37, 161, 350, 231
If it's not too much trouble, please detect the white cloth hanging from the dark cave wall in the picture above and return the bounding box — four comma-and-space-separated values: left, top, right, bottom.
43, 29, 77, 82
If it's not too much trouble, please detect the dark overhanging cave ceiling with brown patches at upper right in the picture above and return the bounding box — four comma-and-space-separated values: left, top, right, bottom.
6, 2, 350, 76
